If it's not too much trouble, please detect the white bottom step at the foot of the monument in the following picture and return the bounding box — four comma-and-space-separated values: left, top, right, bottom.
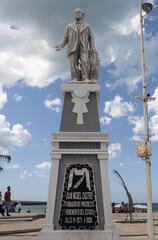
39, 229, 119, 240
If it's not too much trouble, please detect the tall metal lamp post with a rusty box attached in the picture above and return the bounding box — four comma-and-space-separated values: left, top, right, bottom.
136, 0, 155, 240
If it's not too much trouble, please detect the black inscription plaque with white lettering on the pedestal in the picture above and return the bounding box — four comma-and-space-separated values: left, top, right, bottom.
59, 164, 99, 230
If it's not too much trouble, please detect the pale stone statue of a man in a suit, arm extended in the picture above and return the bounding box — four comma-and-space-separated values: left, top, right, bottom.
55, 8, 100, 83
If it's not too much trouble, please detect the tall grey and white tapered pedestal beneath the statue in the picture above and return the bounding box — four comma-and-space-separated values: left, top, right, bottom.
39, 84, 119, 240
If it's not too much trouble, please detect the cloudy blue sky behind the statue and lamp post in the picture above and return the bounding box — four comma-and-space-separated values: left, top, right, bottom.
0, 0, 158, 202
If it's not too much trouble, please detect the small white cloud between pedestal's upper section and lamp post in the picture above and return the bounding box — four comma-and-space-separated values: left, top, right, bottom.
104, 95, 134, 118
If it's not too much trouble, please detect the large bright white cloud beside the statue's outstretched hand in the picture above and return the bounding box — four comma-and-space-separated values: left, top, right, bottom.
0, 22, 69, 87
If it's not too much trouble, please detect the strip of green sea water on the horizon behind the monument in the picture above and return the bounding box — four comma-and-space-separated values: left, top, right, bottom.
21, 203, 158, 213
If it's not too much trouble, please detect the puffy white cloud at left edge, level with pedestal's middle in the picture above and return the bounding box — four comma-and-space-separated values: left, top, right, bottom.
0, 114, 31, 152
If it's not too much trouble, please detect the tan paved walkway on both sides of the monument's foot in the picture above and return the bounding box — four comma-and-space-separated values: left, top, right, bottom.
0, 213, 158, 240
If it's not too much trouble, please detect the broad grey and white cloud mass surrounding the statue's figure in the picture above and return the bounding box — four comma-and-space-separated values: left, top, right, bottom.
0, 0, 158, 91
